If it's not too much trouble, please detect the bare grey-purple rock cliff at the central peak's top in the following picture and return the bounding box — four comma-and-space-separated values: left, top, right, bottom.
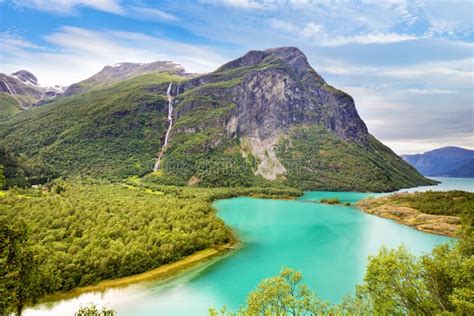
180, 47, 367, 142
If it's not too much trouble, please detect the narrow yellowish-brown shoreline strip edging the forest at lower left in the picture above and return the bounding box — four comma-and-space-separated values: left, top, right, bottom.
40, 241, 239, 302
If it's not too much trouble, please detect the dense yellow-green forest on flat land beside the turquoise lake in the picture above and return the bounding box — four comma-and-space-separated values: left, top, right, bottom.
0, 180, 301, 308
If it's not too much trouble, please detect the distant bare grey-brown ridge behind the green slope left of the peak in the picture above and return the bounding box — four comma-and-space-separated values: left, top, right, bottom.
65, 61, 187, 96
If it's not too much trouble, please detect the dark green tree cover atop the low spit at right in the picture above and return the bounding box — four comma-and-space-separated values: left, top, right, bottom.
374, 190, 474, 216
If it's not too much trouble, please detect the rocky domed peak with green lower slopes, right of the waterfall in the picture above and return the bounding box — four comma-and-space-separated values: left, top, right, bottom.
159, 47, 429, 191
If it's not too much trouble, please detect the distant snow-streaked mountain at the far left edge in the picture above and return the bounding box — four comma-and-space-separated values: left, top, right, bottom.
0, 70, 64, 119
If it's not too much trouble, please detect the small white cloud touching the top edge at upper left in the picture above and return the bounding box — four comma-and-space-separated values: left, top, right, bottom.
14, 0, 124, 14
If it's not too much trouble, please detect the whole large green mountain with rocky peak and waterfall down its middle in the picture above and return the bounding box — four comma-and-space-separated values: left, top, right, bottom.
0, 47, 434, 191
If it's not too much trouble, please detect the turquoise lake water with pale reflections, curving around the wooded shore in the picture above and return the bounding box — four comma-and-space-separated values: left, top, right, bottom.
25, 178, 474, 315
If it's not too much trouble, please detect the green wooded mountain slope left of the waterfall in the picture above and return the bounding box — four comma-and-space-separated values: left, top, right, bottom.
0, 73, 180, 179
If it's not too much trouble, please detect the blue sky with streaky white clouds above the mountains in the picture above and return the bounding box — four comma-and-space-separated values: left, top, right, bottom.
0, 0, 474, 154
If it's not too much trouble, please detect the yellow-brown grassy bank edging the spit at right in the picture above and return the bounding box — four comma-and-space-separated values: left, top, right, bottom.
356, 193, 462, 238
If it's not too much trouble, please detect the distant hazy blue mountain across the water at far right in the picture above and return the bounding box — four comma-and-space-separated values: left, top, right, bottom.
402, 147, 474, 178
